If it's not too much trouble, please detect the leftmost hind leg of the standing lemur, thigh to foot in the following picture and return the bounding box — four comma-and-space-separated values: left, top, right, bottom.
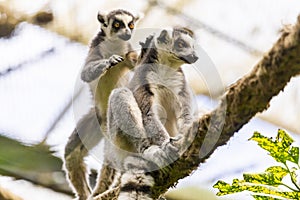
64, 109, 103, 200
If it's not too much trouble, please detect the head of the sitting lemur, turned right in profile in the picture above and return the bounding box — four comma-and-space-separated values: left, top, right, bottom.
157, 28, 198, 64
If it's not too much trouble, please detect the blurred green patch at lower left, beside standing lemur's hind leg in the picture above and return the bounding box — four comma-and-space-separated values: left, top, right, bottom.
0, 134, 70, 194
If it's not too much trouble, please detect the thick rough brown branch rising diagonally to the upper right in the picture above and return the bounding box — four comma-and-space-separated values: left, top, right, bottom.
152, 16, 300, 199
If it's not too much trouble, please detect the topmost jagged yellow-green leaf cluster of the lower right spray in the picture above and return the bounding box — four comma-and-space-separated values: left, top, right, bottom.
250, 130, 299, 164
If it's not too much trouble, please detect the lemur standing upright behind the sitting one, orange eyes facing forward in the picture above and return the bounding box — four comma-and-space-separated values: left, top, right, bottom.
64, 10, 139, 200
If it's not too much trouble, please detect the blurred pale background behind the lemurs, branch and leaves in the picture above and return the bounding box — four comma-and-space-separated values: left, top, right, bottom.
0, 0, 300, 200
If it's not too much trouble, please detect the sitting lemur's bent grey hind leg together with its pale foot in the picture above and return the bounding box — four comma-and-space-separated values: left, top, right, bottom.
108, 88, 178, 168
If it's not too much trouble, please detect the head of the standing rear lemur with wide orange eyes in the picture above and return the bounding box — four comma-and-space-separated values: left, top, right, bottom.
98, 9, 141, 41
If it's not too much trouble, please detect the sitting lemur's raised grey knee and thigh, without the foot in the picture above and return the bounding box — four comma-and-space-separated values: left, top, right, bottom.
107, 88, 149, 153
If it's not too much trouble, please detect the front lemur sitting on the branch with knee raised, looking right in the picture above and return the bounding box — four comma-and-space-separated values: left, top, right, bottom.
94, 28, 198, 200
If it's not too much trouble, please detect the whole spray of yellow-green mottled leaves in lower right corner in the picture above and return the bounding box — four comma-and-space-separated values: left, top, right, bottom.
214, 130, 300, 200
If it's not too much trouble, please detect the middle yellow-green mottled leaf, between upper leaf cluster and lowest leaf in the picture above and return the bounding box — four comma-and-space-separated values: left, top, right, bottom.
243, 166, 289, 186
